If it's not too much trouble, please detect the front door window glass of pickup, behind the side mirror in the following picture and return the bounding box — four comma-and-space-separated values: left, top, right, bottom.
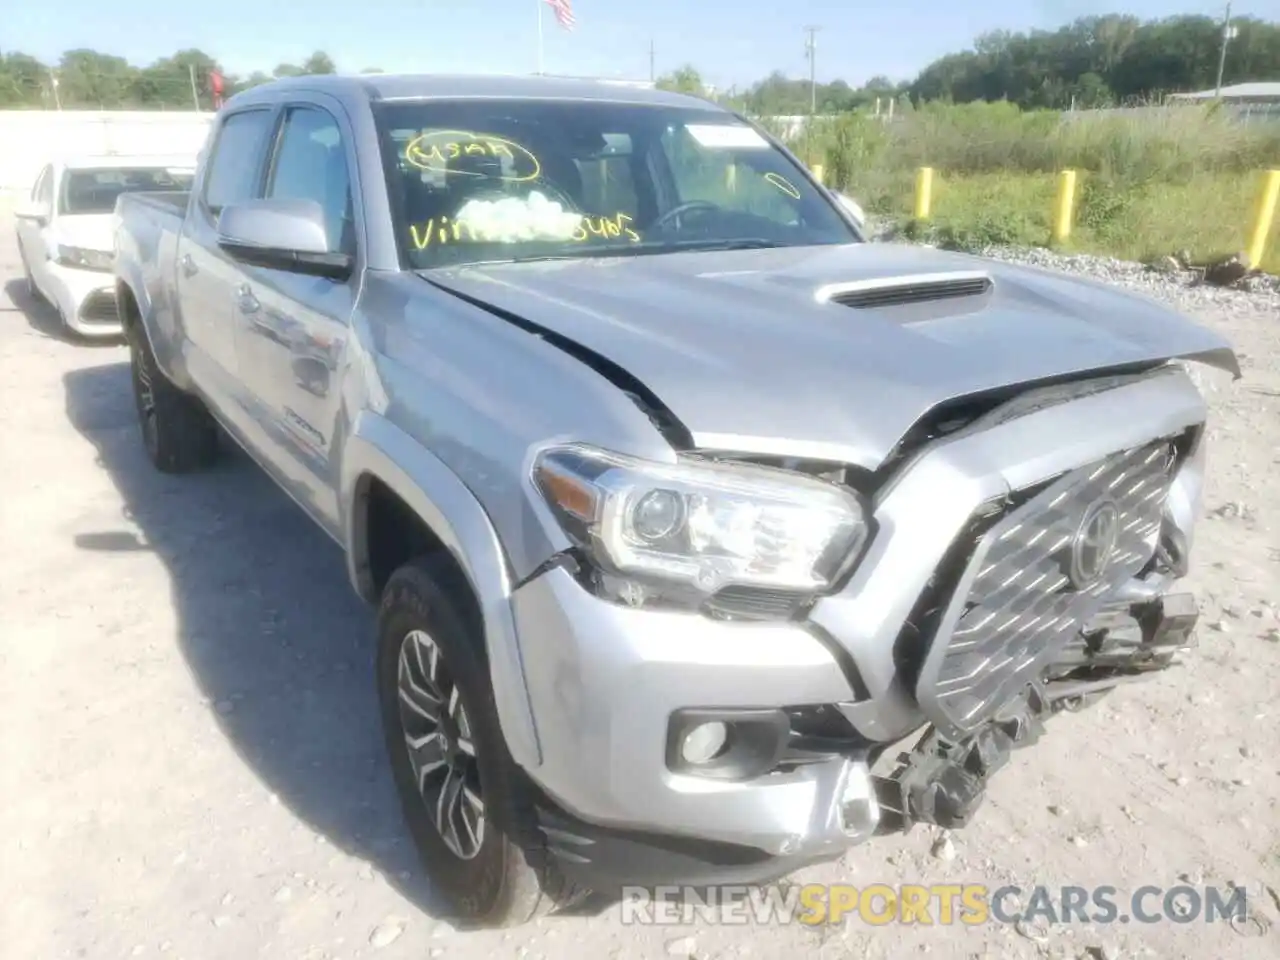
266, 106, 355, 253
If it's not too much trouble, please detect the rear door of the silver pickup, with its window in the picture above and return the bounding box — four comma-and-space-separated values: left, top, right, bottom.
174, 106, 275, 414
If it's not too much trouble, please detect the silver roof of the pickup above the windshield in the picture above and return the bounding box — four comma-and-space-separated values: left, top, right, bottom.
233, 73, 721, 109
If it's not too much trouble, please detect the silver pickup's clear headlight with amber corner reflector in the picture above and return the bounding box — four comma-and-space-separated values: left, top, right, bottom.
534, 444, 868, 616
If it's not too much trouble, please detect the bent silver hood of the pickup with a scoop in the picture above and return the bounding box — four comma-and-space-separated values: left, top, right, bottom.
421, 243, 1239, 468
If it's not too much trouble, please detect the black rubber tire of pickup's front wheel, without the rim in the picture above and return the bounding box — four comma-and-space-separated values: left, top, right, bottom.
376, 558, 585, 928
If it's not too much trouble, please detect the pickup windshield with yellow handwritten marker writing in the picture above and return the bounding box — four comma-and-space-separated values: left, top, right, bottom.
376, 99, 860, 269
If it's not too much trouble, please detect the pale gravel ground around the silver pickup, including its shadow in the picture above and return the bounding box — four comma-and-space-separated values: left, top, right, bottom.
0, 207, 1280, 960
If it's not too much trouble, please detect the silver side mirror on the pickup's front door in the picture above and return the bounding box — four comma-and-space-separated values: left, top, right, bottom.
218, 198, 353, 280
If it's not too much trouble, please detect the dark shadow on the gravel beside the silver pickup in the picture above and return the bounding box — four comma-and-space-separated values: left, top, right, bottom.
64, 364, 450, 914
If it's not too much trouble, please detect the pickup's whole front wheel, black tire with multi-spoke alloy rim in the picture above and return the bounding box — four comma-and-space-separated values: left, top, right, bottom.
378, 561, 576, 927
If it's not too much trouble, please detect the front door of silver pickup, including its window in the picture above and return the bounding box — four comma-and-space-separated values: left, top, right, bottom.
236, 102, 360, 535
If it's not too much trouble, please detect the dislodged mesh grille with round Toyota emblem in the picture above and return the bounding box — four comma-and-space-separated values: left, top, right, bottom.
916, 440, 1175, 736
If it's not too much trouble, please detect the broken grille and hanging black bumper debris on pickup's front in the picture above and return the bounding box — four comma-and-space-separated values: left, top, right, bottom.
874, 417, 1203, 832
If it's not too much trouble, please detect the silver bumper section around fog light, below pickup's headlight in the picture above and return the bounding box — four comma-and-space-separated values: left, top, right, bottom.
513, 567, 869, 856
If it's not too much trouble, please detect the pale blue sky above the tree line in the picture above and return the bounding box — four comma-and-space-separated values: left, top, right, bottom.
10, 0, 1280, 87
